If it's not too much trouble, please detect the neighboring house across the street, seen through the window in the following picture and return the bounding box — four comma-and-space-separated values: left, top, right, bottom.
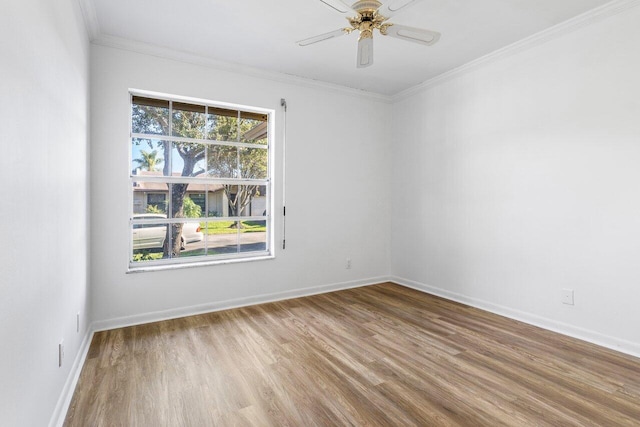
133, 170, 267, 216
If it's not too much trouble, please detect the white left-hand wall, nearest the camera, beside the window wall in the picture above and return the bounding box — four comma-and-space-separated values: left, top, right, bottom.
0, 0, 89, 426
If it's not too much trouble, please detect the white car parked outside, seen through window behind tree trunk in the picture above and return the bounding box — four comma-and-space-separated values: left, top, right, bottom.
133, 214, 204, 250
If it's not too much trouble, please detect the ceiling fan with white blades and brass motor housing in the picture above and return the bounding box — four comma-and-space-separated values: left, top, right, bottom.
296, 0, 440, 68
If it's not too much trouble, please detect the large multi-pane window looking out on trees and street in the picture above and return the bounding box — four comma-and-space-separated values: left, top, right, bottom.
129, 92, 272, 269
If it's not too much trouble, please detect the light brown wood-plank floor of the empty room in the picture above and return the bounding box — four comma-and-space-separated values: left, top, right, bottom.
65, 283, 640, 427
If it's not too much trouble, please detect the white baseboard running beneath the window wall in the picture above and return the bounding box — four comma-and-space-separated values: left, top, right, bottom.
93, 276, 390, 332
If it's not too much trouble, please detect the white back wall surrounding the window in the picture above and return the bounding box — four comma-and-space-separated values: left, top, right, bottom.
90, 46, 390, 328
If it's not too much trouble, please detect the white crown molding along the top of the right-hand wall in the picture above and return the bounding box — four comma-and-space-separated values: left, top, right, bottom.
391, 0, 640, 103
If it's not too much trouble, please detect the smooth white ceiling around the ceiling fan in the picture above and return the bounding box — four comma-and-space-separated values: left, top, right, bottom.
85, 0, 609, 95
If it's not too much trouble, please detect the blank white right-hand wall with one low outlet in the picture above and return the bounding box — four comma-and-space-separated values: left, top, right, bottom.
392, 7, 640, 354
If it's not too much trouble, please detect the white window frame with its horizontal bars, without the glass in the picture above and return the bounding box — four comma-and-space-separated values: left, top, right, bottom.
127, 89, 275, 273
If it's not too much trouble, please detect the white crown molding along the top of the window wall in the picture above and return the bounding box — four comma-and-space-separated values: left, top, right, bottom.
90, 33, 391, 104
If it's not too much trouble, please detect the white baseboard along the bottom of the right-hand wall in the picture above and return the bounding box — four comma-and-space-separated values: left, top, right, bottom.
389, 276, 640, 357
